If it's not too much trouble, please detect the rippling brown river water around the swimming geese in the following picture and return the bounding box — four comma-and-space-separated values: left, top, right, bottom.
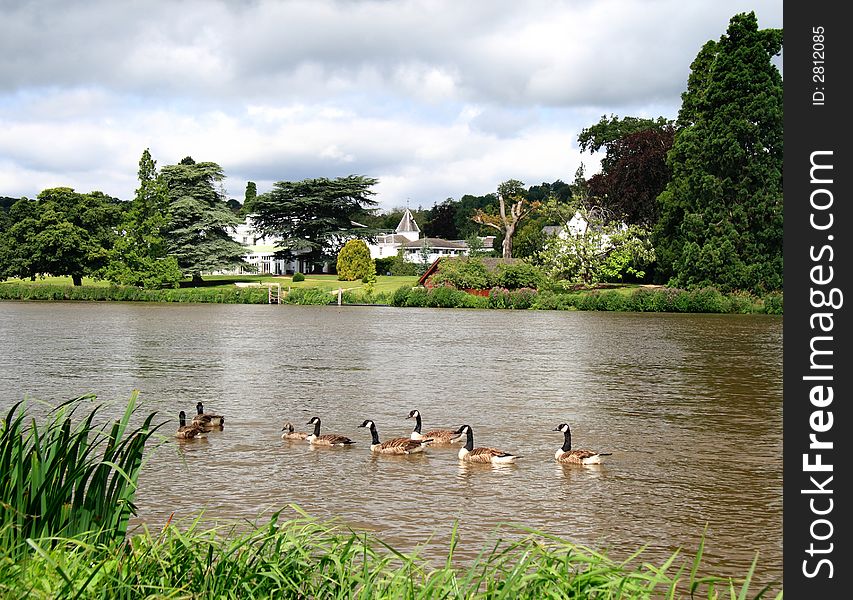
0, 302, 782, 591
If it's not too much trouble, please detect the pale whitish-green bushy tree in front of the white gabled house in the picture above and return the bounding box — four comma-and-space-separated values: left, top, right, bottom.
538, 207, 655, 285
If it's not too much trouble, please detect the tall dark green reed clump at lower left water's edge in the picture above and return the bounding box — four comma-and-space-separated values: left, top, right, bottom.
0, 391, 162, 555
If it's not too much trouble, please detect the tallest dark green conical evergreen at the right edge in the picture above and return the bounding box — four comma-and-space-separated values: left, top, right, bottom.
654, 12, 783, 293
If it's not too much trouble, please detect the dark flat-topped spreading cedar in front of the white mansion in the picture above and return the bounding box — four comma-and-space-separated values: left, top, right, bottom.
253, 175, 377, 270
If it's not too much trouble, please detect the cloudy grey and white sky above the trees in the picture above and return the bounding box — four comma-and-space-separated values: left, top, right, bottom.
0, 0, 782, 211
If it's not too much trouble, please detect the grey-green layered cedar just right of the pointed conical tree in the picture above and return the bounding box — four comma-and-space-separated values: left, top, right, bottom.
160, 156, 250, 283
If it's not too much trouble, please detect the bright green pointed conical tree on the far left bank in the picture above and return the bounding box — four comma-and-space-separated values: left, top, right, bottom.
100, 148, 182, 288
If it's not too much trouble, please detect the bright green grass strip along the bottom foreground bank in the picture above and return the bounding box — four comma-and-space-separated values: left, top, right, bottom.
0, 507, 782, 600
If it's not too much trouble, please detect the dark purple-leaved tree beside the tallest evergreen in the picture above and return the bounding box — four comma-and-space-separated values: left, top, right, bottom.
588, 123, 675, 227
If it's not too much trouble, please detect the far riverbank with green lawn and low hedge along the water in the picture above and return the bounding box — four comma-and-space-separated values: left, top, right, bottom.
0, 275, 783, 315
